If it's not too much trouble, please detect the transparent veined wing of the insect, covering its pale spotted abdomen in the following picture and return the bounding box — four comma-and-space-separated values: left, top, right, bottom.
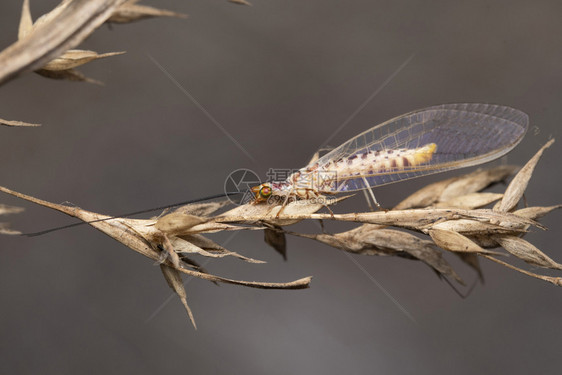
301, 103, 529, 193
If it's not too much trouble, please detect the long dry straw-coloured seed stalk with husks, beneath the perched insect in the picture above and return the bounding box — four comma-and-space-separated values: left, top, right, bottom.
0, 140, 562, 326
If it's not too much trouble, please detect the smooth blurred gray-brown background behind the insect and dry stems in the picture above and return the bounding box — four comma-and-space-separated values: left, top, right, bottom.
0, 0, 562, 374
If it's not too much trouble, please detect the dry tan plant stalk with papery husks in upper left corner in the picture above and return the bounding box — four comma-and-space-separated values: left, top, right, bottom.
0, 0, 247, 85
